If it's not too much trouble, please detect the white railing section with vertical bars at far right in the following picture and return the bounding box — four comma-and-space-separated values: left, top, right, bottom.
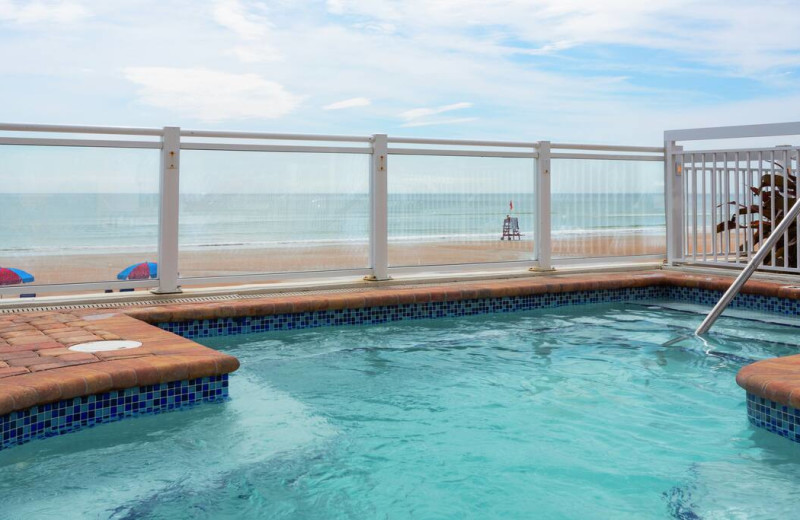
665, 123, 800, 273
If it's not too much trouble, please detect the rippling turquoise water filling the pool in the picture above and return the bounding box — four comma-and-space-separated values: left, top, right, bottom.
0, 304, 800, 520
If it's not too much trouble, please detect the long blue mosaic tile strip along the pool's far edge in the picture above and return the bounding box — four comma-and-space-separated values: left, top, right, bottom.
158, 287, 665, 339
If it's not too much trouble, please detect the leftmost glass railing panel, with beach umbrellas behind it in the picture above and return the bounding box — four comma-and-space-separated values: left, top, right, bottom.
0, 145, 159, 293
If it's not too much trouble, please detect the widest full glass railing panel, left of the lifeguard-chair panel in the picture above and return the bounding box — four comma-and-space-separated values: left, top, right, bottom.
179, 150, 370, 278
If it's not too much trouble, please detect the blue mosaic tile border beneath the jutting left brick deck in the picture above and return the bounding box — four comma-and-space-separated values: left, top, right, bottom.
0, 374, 228, 450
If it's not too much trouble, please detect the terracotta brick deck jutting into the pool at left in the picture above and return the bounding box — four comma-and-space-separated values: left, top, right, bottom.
0, 310, 239, 415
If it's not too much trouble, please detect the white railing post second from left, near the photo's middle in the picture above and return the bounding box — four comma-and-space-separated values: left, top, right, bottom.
364, 134, 389, 281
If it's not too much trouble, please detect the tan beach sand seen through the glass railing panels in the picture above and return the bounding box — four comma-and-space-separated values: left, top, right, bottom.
0, 235, 665, 292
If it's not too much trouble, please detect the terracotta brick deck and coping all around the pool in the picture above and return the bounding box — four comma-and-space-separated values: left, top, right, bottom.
0, 270, 800, 422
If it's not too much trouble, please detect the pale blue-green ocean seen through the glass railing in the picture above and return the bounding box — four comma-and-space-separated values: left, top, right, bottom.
0, 193, 664, 258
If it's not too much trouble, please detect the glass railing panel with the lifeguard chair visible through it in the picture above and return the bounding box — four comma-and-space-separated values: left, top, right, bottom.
388, 155, 535, 267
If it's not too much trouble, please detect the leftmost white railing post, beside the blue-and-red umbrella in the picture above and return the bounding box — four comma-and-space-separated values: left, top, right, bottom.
153, 126, 181, 294
